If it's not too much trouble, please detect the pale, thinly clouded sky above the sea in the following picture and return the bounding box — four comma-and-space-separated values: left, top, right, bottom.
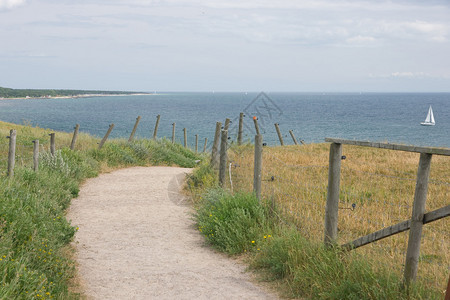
0, 0, 450, 92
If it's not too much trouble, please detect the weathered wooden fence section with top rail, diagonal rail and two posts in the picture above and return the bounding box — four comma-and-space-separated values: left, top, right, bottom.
325, 138, 450, 286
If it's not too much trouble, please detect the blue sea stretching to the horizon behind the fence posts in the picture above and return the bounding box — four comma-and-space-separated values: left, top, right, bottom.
0, 93, 450, 147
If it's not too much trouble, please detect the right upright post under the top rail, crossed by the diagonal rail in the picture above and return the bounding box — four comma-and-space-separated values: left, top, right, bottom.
404, 153, 432, 287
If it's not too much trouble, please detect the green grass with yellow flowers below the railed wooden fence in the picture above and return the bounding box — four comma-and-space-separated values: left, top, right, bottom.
252, 227, 440, 299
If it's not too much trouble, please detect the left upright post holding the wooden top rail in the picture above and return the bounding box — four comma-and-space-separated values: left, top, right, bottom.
324, 143, 342, 246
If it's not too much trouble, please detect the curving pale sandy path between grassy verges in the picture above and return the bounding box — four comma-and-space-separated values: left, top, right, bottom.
68, 167, 276, 299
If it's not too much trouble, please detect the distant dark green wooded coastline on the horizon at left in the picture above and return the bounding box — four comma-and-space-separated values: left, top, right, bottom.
0, 87, 144, 98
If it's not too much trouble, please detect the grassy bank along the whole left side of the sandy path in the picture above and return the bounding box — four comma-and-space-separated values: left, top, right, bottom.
0, 123, 201, 299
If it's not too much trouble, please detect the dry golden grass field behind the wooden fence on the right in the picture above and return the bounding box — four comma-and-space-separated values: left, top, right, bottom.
229, 144, 450, 290
